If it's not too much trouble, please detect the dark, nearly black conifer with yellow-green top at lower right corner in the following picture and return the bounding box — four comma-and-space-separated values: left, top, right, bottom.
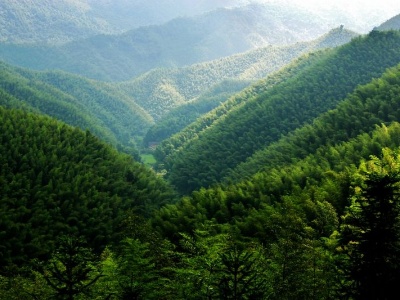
341, 149, 400, 299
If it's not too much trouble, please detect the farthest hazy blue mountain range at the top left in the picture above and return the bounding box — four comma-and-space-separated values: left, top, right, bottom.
0, 0, 247, 44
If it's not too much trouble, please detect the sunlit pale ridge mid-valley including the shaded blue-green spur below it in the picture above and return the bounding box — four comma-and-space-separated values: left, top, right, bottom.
125, 28, 356, 142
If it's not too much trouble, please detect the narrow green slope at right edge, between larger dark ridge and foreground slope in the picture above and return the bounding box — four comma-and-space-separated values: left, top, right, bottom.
225, 65, 400, 182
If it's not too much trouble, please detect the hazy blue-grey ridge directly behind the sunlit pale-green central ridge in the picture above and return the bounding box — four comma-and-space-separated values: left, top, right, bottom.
0, 4, 340, 81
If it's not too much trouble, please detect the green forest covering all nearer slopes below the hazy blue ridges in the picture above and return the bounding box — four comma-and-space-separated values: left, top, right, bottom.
0, 6, 400, 300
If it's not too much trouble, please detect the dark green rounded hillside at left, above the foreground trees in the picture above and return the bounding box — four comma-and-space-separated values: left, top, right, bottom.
0, 107, 173, 266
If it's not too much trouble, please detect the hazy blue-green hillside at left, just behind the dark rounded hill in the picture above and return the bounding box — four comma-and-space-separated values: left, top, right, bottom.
0, 63, 153, 152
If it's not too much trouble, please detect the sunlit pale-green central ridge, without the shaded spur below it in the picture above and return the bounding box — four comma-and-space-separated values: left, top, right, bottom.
118, 28, 357, 124
